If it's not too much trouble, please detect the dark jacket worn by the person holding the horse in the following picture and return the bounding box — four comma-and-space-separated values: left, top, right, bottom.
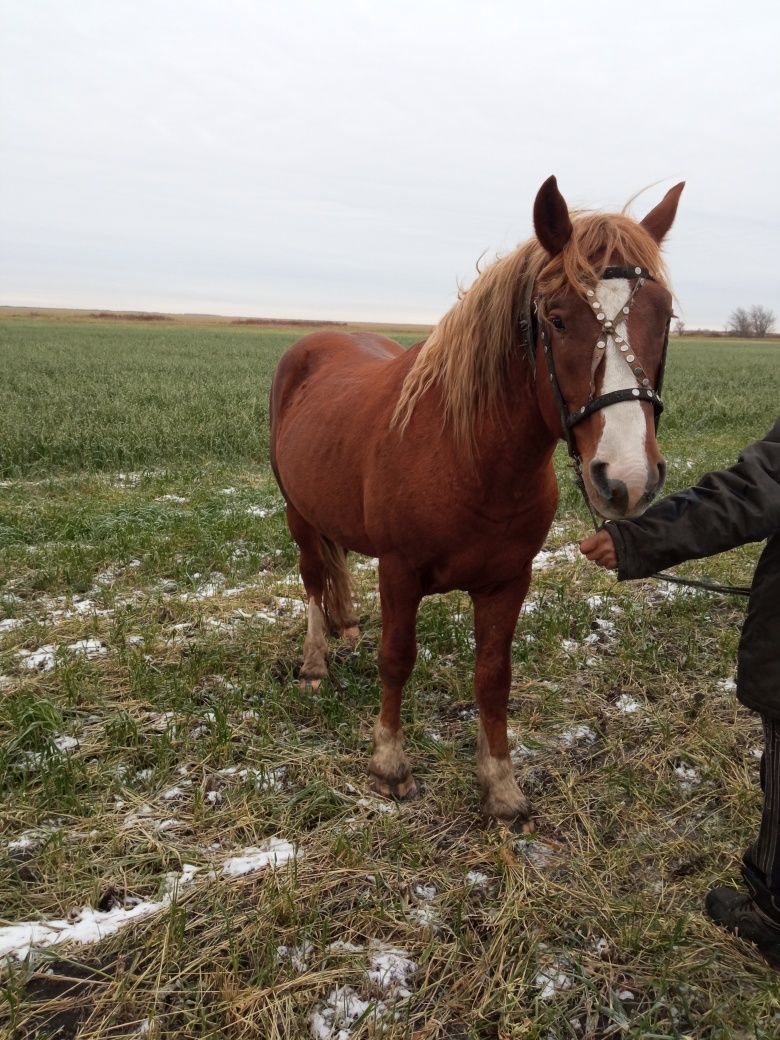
606, 420, 780, 721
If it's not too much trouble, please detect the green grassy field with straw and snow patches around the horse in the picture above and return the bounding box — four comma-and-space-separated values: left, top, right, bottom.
0, 317, 780, 1040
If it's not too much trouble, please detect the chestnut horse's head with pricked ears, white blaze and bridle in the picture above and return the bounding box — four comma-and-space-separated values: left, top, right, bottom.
528, 177, 684, 519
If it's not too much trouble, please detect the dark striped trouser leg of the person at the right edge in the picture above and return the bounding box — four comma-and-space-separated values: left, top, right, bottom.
743, 717, 780, 921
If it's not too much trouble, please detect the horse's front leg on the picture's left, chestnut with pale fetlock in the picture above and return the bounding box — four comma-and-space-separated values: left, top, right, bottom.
368, 556, 422, 799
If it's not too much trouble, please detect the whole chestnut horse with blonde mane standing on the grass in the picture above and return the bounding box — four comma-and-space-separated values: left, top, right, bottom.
269, 177, 684, 832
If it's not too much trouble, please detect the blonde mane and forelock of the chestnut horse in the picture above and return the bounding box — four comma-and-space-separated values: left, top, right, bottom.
392, 212, 667, 449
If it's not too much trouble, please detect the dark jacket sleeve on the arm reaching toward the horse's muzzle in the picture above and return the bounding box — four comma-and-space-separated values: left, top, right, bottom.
606, 419, 780, 581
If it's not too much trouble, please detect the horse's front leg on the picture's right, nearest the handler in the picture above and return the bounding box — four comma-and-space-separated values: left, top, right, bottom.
471, 568, 534, 833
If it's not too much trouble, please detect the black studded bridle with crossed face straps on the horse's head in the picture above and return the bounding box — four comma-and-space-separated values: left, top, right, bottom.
520, 267, 670, 513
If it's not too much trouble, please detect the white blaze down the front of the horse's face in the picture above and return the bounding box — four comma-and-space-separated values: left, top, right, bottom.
594, 278, 648, 484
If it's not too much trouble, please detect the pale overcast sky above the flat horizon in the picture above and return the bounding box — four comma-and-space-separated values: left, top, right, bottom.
0, 0, 780, 328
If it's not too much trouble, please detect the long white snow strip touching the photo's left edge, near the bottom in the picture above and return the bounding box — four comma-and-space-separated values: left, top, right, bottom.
0, 864, 198, 961
